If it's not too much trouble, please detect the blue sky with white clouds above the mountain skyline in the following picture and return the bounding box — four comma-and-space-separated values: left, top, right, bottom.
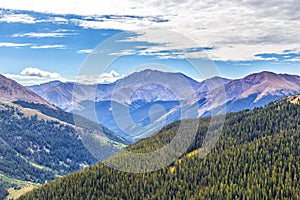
0, 0, 300, 85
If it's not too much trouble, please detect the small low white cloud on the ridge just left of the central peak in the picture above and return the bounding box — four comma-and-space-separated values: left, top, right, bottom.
76, 70, 124, 84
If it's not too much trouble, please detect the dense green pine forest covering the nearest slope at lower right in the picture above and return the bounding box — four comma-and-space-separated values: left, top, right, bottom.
20, 96, 300, 200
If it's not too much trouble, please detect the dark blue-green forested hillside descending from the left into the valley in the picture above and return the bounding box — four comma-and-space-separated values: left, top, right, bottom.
0, 101, 126, 199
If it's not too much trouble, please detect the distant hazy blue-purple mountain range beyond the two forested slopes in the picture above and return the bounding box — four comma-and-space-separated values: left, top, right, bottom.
28, 70, 300, 139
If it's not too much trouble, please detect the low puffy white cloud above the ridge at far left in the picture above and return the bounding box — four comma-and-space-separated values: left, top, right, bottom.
4, 67, 70, 86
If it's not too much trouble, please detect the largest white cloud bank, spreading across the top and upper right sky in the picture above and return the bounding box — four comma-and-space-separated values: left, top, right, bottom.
0, 0, 300, 61
